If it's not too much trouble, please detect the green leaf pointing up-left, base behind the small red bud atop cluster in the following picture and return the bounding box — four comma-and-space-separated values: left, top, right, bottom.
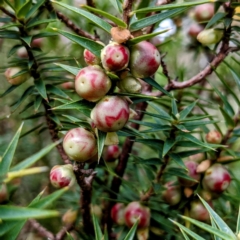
54, 28, 104, 57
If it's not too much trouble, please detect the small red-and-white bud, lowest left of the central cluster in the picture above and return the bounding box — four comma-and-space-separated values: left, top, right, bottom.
50, 164, 76, 188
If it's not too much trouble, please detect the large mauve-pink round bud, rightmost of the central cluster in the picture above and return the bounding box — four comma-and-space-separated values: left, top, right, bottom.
130, 41, 160, 78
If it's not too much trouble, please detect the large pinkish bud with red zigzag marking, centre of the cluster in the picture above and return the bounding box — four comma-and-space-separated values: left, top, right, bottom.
91, 96, 130, 132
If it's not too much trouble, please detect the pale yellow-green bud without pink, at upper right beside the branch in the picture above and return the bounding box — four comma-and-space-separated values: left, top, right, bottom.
197, 28, 223, 45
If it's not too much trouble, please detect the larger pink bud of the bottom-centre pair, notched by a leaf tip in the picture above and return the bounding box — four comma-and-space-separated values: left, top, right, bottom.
124, 202, 150, 228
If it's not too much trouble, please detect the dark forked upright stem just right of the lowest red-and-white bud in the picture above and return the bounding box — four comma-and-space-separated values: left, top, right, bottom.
74, 163, 97, 234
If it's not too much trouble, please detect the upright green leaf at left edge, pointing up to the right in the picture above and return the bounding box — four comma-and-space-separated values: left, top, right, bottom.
0, 123, 23, 177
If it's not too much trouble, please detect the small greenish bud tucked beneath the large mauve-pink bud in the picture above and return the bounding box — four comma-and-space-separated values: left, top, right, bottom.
117, 74, 142, 93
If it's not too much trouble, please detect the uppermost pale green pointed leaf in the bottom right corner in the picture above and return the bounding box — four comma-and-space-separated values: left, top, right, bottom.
199, 196, 236, 240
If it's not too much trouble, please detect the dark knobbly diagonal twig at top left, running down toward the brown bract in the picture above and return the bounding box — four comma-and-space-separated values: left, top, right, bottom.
45, 1, 98, 41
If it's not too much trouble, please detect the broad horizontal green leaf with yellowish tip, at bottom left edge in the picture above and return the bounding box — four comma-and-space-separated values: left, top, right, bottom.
0, 205, 59, 220
